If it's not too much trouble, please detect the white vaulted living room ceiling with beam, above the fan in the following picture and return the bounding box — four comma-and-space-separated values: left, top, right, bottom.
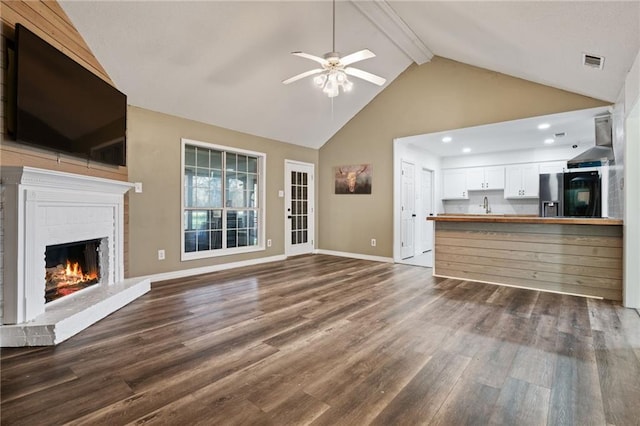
60, 0, 640, 148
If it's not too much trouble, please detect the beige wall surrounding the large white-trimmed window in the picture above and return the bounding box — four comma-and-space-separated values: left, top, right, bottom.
127, 107, 318, 276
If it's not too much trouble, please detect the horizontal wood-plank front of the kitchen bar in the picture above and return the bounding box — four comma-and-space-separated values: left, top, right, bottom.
427, 214, 622, 301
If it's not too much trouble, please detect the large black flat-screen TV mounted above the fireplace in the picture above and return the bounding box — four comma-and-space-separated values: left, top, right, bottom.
13, 24, 127, 166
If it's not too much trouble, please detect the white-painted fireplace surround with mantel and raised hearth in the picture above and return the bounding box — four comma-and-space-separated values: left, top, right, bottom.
2, 167, 149, 346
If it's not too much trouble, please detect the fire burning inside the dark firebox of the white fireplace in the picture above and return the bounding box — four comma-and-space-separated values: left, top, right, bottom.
45, 239, 101, 303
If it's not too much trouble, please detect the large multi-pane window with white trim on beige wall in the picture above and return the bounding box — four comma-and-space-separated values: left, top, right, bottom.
182, 139, 266, 260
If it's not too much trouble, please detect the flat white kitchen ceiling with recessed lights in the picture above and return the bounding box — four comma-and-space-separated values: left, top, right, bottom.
400, 107, 610, 157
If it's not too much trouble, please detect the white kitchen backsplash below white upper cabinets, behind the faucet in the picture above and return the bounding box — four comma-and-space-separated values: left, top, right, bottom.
443, 191, 539, 216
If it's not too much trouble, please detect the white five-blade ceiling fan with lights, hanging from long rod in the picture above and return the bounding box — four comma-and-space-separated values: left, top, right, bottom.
282, 0, 387, 98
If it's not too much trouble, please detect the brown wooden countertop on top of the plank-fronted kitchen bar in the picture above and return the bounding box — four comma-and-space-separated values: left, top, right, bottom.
427, 213, 623, 225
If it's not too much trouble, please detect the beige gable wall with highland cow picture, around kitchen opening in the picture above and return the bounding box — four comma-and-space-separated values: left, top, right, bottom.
317, 57, 607, 257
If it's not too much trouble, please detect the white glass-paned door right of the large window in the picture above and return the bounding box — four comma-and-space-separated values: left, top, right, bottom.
284, 160, 315, 256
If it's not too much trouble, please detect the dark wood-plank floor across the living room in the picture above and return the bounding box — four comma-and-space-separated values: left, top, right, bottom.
0, 255, 640, 425
